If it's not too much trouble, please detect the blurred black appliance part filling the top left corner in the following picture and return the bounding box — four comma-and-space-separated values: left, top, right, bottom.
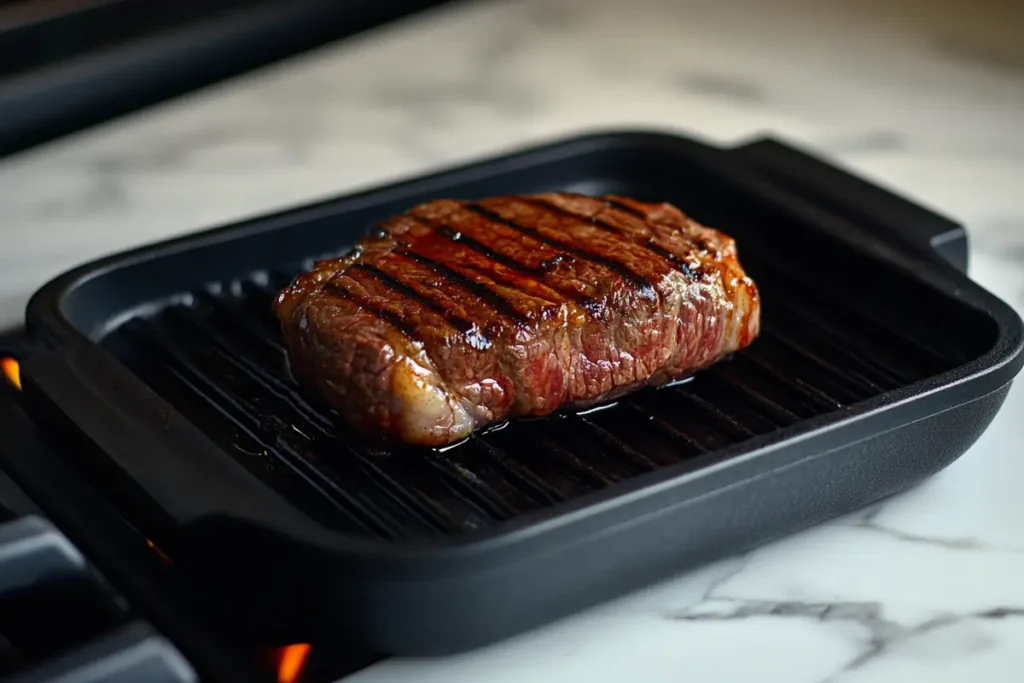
0, 0, 456, 154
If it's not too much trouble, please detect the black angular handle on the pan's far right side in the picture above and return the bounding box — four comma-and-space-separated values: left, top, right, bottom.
729, 137, 968, 273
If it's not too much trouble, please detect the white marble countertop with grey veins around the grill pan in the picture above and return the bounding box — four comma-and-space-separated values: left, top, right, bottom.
0, 0, 1024, 683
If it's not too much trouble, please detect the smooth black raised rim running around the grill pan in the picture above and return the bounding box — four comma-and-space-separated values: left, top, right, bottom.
18, 131, 1024, 568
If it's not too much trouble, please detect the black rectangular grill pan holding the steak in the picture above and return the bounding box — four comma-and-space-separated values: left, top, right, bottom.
16, 132, 1024, 655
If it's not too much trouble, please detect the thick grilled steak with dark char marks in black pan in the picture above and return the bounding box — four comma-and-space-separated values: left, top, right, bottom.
275, 194, 760, 446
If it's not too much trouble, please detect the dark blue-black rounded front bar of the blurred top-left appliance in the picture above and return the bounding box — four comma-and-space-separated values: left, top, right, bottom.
0, 0, 453, 158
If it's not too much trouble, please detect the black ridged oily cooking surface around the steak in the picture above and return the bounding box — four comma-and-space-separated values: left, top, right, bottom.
104, 252, 968, 539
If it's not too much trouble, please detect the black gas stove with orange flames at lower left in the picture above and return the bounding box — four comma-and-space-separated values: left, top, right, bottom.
0, 331, 379, 683
